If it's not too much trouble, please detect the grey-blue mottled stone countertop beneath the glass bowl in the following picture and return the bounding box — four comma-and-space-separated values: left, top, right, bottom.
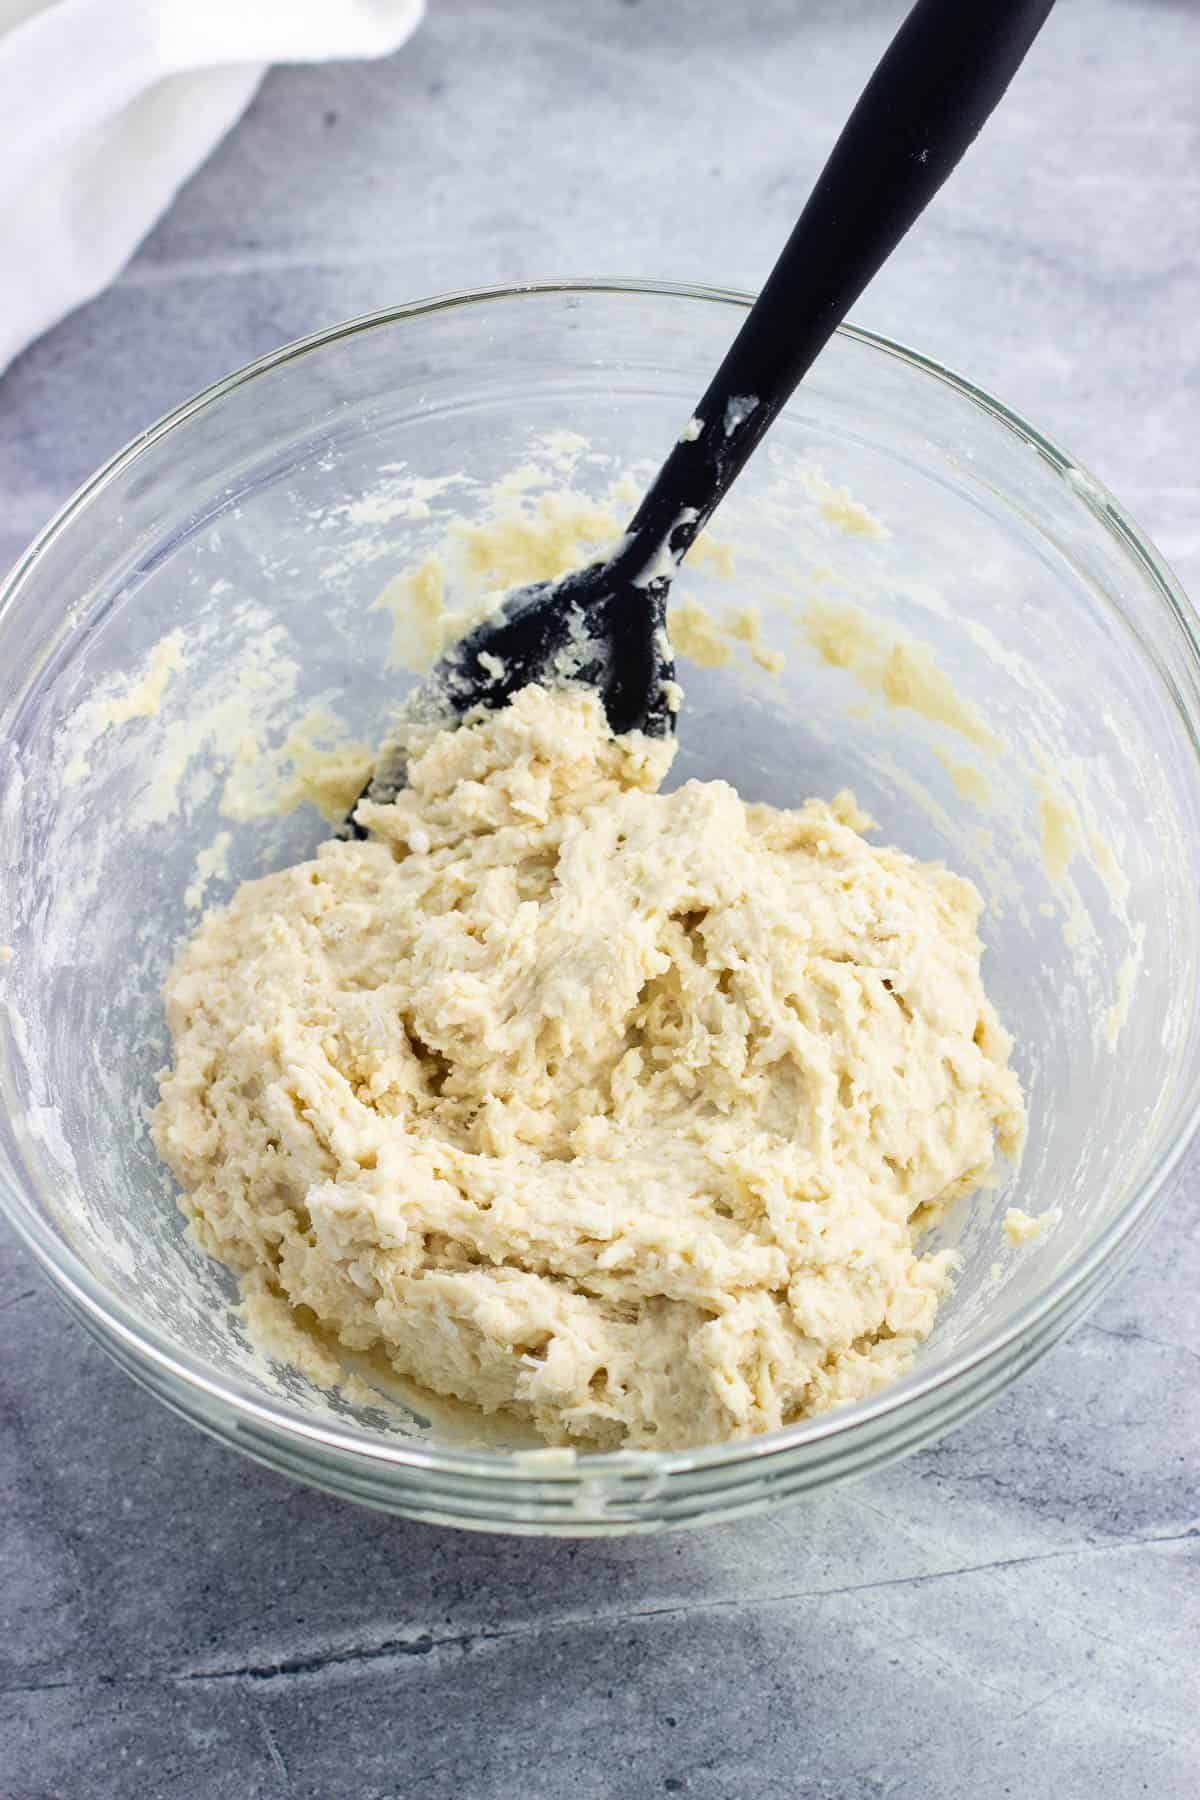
0, 0, 1200, 1800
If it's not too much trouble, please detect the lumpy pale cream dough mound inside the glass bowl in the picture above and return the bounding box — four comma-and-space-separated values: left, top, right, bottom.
153, 688, 1024, 1447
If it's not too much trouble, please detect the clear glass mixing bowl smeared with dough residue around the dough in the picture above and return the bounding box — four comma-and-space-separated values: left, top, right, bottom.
0, 281, 1200, 1534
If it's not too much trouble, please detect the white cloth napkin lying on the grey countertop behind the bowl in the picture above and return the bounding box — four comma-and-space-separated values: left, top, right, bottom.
0, 0, 425, 371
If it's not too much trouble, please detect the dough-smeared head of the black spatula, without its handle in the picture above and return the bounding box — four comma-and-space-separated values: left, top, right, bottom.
352, 563, 678, 837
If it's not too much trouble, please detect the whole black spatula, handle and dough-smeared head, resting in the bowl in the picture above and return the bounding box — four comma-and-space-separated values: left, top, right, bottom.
351, 0, 1052, 832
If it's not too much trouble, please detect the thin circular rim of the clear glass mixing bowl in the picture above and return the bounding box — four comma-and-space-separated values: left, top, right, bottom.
0, 277, 1200, 1503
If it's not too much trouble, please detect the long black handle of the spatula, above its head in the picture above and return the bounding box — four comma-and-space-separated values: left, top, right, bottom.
621, 0, 1052, 572
